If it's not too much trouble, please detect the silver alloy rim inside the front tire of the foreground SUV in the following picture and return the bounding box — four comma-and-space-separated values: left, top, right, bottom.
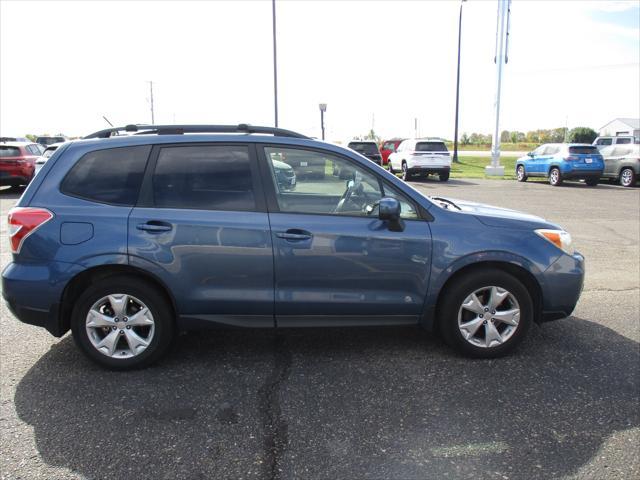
458, 286, 520, 348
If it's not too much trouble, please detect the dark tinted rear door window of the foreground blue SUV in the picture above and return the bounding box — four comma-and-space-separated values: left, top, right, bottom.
153, 145, 256, 211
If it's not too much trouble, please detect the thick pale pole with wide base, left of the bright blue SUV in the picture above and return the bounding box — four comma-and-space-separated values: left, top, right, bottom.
485, 0, 511, 176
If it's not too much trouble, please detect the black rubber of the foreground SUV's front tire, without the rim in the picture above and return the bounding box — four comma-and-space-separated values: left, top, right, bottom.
438, 269, 533, 358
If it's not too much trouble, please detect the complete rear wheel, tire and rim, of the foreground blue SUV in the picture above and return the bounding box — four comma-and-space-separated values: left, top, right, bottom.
71, 276, 174, 370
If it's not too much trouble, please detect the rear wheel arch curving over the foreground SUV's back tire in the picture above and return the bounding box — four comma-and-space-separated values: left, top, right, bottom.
58, 264, 178, 333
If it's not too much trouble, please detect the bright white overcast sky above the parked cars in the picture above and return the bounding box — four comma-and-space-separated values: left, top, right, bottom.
0, 0, 640, 140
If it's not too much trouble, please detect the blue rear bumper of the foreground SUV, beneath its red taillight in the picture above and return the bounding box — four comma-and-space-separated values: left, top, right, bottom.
2, 262, 83, 337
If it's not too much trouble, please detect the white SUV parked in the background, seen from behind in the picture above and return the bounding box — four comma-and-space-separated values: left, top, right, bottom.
389, 138, 451, 182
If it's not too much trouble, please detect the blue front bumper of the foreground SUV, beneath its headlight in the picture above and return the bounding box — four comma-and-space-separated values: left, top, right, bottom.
540, 252, 585, 322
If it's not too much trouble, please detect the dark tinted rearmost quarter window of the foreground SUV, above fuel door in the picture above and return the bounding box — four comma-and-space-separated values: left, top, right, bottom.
60, 145, 151, 206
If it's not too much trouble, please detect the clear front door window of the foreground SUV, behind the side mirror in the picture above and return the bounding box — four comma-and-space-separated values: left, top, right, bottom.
265, 147, 417, 219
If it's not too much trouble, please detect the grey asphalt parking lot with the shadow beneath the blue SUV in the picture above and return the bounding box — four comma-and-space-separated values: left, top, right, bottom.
0, 179, 640, 479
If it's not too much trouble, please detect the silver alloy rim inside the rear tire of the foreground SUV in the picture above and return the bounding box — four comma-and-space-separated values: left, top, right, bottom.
85, 293, 155, 358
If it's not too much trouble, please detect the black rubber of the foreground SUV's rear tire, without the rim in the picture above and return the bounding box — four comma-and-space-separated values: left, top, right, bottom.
71, 276, 175, 370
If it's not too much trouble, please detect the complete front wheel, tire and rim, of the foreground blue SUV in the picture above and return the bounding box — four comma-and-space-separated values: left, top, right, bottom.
438, 270, 533, 358
